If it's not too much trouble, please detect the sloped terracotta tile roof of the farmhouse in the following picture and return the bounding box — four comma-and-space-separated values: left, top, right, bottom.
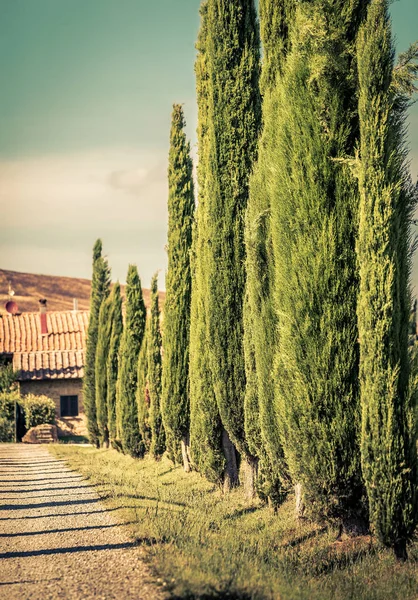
0, 311, 89, 381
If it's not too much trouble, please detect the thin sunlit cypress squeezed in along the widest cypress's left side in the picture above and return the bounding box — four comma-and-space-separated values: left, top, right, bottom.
244, 0, 294, 504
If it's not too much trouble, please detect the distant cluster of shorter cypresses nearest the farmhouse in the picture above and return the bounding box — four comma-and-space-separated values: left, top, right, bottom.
83, 246, 165, 457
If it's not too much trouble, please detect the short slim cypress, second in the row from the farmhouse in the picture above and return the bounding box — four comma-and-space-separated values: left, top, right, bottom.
95, 296, 112, 448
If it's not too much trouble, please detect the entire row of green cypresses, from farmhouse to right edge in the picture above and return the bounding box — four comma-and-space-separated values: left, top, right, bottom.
85, 0, 418, 558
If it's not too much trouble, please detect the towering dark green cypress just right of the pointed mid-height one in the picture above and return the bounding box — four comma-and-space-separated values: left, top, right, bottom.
205, 0, 261, 485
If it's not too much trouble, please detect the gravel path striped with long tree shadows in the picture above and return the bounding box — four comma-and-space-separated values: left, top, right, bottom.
0, 444, 167, 600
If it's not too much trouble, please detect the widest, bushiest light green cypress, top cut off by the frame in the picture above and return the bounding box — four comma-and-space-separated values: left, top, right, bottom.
268, 0, 367, 524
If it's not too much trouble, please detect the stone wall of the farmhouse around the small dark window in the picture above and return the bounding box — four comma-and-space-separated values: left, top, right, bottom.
19, 379, 87, 436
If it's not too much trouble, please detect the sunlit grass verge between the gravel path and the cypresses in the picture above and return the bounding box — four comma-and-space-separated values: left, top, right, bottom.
49, 445, 418, 600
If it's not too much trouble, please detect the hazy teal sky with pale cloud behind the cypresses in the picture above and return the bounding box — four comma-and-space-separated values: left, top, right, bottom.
0, 0, 418, 294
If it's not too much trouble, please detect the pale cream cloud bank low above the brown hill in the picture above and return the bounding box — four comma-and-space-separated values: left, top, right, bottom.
0, 147, 168, 280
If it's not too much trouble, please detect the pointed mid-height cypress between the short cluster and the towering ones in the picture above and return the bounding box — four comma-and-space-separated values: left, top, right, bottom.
161, 104, 194, 472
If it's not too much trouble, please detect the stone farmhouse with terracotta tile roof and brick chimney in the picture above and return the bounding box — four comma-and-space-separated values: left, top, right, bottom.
0, 300, 89, 435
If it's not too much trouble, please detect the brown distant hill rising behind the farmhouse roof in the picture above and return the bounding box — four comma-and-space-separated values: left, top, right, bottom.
0, 269, 165, 313
